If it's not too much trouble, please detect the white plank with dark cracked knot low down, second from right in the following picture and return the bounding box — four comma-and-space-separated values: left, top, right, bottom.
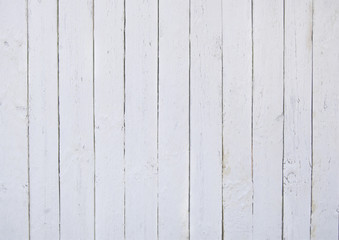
283, 0, 312, 239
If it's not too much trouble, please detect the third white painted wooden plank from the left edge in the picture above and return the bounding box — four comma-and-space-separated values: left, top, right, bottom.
59, 0, 94, 239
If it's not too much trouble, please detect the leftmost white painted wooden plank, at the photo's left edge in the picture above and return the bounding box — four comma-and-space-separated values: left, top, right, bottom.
0, 1, 29, 240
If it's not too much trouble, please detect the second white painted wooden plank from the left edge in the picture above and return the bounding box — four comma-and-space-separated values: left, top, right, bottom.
28, 1, 59, 239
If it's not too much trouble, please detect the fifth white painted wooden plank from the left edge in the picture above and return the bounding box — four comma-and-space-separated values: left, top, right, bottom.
125, 0, 158, 240
